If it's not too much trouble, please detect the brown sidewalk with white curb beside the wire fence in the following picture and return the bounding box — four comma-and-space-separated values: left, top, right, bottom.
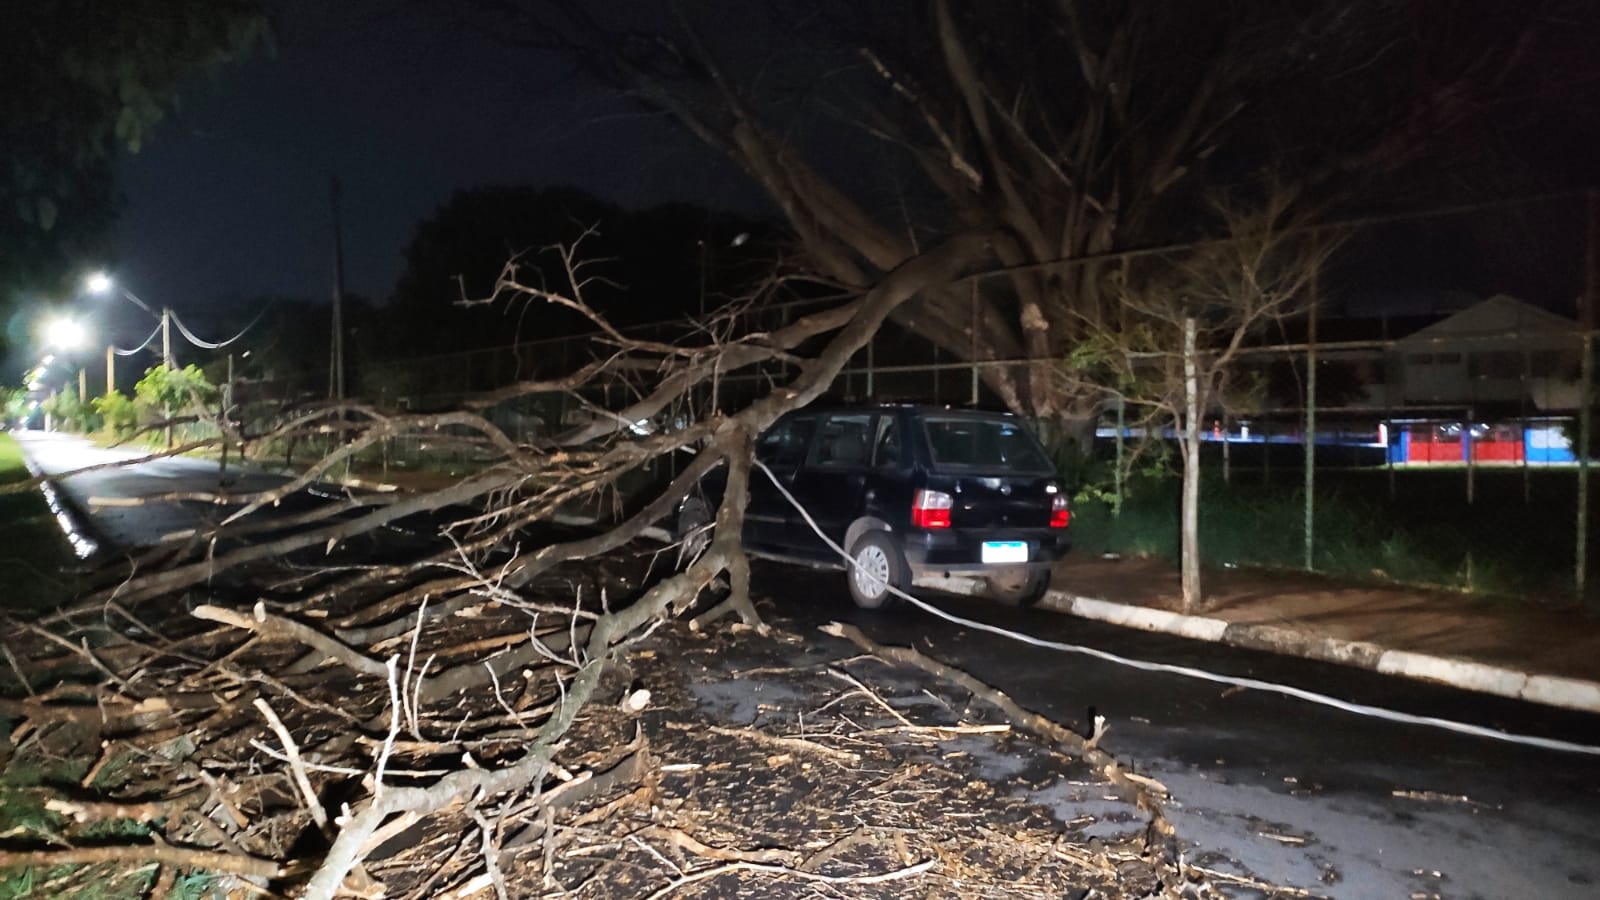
1040, 554, 1600, 713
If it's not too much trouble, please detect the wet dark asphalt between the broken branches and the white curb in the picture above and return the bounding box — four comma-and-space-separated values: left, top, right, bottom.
754, 565, 1600, 898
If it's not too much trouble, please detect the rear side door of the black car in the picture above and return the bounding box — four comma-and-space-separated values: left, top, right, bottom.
787, 412, 877, 560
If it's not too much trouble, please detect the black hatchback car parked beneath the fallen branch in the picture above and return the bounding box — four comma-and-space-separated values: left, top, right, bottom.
678, 404, 1070, 609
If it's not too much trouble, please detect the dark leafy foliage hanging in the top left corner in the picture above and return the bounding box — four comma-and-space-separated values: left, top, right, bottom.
0, 0, 267, 360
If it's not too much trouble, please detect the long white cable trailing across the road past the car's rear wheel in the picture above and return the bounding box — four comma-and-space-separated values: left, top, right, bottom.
754, 460, 1600, 756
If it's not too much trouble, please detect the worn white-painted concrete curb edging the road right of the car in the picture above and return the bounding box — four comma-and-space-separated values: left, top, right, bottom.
1038, 591, 1600, 713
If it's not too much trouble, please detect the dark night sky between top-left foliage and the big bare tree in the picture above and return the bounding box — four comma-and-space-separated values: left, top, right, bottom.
114, 0, 758, 328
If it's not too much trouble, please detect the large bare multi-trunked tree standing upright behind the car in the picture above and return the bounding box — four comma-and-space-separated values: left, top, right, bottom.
496, 0, 1592, 441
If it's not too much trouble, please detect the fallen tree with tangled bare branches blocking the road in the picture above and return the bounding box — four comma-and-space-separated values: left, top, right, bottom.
0, 235, 1222, 898
